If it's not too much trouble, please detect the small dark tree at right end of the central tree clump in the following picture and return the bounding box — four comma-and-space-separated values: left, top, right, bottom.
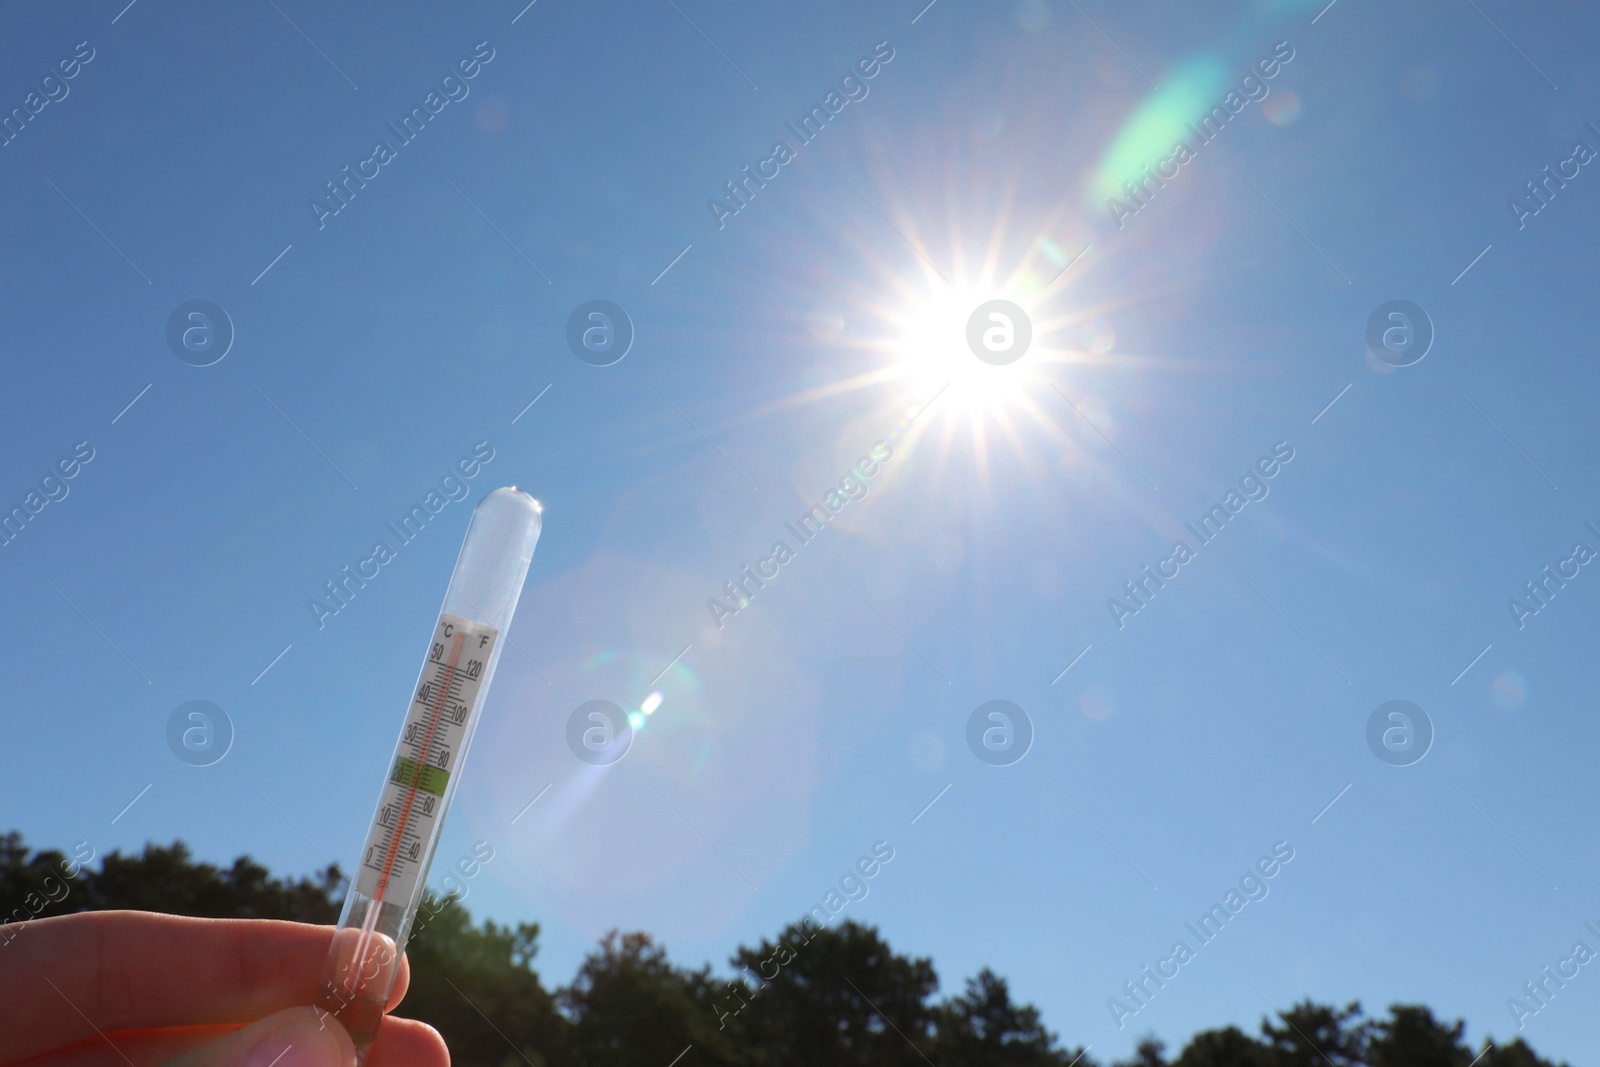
930, 968, 1088, 1067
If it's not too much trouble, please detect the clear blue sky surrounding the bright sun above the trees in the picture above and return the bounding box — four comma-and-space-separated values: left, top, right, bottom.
0, 0, 1600, 1062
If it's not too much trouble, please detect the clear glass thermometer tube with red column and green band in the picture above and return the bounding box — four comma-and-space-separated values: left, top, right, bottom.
317, 486, 541, 1062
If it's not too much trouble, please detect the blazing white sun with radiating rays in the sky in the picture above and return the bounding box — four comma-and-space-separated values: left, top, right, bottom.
739, 147, 1141, 495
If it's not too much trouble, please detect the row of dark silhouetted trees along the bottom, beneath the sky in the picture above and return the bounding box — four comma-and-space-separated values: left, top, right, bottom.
0, 832, 1568, 1067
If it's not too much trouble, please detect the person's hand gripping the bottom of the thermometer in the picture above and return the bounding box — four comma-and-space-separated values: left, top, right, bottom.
0, 912, 450, 1067
